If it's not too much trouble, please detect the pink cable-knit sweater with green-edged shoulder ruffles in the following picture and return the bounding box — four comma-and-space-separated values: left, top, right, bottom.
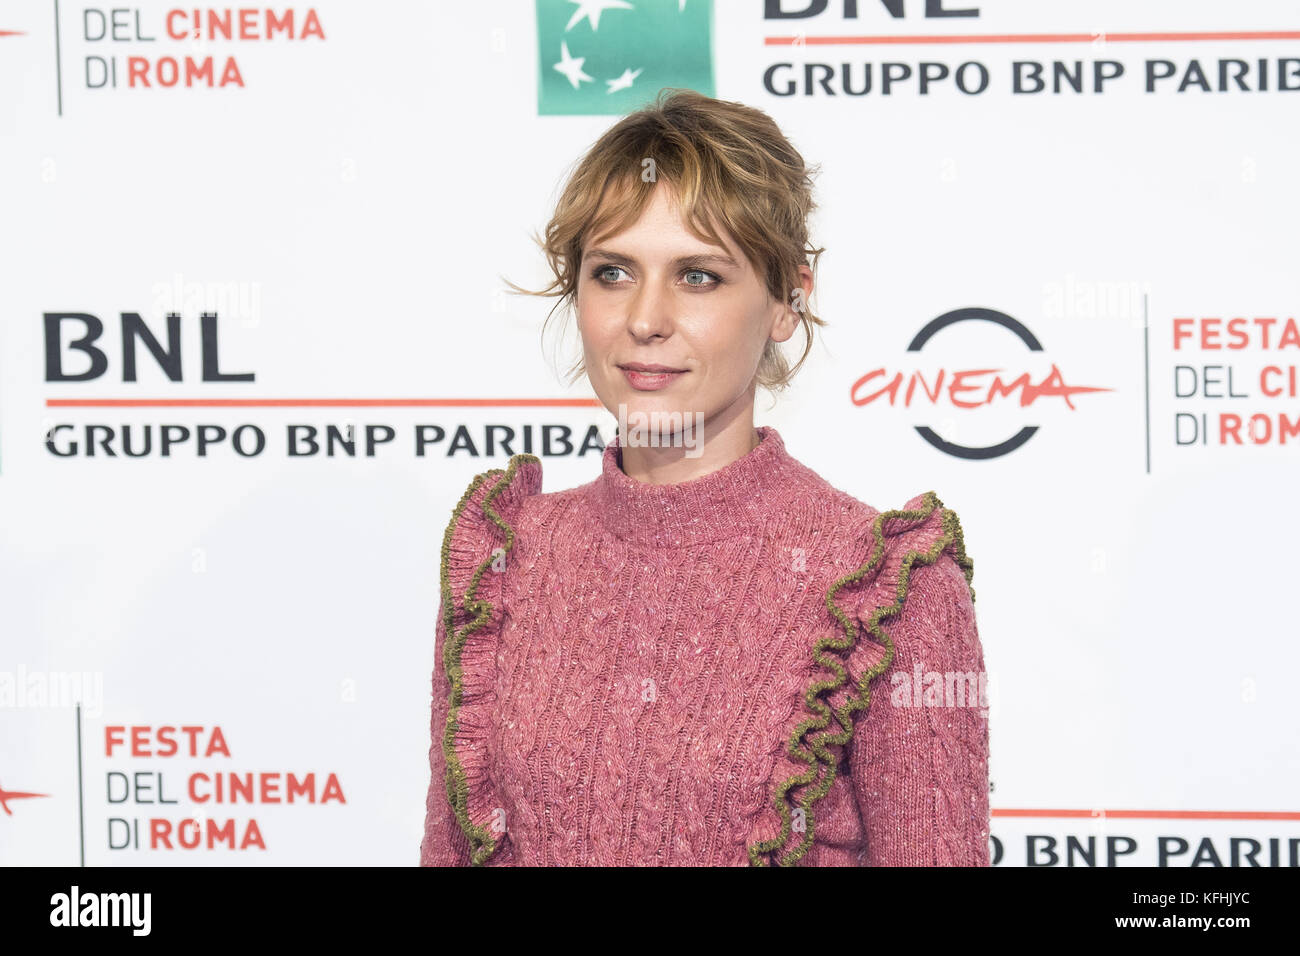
420, 427, 989, 866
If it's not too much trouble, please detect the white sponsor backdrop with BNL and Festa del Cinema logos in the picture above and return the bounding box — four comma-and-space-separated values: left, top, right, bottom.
0, 0, 1300, 866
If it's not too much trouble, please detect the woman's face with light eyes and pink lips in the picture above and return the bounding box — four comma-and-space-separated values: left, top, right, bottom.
577, 183, 811, 442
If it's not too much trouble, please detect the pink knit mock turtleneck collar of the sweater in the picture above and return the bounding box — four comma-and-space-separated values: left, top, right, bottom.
595, 425, 798, 548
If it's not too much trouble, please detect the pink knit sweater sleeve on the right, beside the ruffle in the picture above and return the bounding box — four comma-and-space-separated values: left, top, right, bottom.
849, 550, 989, 866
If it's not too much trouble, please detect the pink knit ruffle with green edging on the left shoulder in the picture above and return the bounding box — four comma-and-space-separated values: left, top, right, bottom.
441, 454, 542, 865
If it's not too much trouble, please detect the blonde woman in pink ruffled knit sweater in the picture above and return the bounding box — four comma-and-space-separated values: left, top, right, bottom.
420, 91, 989, 866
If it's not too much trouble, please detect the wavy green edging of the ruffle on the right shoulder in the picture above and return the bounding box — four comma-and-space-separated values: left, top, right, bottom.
749, 492, 975, 866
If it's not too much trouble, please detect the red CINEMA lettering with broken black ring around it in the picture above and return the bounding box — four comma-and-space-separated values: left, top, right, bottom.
849, 308, 1114, 459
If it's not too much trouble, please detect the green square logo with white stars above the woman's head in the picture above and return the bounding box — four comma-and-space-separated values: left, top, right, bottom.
537, 0, 715, 116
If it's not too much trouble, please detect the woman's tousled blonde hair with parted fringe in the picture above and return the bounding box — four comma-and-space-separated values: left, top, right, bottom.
506, 87, 826, 392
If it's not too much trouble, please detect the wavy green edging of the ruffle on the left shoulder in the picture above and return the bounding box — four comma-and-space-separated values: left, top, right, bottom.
439, 454, 541, 866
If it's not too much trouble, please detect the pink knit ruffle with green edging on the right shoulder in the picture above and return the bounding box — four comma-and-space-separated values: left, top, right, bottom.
749, 492, 975, 866
